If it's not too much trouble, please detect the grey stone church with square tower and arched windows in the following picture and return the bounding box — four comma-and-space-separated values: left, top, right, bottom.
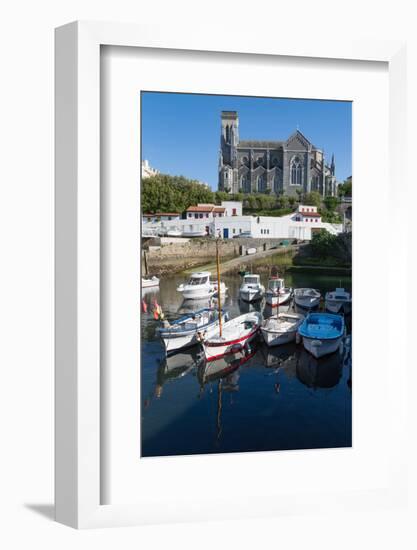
219, 111, 337, 196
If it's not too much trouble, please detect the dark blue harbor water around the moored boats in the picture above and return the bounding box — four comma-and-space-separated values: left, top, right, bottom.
140, 272, 352, 457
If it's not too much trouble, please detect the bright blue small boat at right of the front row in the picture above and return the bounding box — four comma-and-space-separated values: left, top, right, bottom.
298, 313, 345, 359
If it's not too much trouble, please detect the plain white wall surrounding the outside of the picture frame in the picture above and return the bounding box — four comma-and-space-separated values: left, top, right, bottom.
0, 0, 417, 550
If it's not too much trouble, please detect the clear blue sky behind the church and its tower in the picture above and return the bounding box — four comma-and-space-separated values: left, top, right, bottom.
142, 92, 352, 190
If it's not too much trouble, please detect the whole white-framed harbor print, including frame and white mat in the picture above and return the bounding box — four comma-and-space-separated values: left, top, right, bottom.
56, 23, 406, 527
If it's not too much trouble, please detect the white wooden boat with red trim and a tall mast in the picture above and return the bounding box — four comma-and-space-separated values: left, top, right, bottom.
203, 311, 262, 361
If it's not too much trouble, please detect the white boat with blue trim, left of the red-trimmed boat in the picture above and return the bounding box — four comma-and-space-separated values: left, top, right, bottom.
157, 308, 228, 354
